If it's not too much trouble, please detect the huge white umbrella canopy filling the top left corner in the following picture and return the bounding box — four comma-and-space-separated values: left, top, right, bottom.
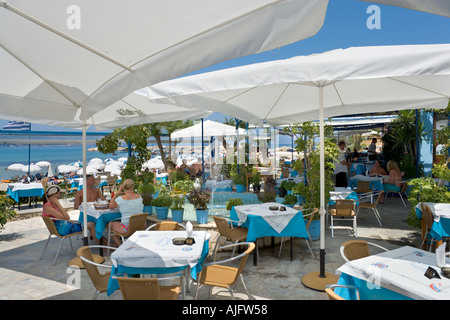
0, 0, 328, 125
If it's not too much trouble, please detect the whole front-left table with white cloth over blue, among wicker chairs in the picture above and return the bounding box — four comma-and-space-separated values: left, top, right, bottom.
107, 230, 211, 296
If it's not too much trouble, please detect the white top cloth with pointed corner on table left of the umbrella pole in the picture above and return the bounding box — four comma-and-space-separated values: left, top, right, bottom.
234, 202, 298, 233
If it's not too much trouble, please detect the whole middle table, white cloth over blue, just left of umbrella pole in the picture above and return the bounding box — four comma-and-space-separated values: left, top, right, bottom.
230, 202, 310, 265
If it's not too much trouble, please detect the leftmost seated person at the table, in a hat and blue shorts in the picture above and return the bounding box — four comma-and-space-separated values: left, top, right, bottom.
42, 185, 82, 236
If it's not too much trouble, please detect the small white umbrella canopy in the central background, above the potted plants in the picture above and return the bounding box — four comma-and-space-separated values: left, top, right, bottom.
170, 120, 246, 140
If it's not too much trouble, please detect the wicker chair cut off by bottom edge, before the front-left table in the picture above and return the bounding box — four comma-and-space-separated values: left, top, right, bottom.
117, 273, 183, 300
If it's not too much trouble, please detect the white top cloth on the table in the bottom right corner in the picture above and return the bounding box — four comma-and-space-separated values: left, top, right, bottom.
336, 246, 450, 300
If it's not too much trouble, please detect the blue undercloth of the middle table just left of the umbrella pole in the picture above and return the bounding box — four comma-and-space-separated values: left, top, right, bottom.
230, 207, 309, 242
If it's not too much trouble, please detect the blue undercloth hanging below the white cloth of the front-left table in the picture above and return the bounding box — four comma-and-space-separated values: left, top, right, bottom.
106, 240, 209, 296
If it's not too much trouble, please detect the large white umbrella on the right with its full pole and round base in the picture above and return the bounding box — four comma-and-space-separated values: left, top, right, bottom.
148, 44, 450, 290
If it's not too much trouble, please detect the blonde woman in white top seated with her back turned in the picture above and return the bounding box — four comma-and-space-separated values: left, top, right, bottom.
109, 179, 144, 244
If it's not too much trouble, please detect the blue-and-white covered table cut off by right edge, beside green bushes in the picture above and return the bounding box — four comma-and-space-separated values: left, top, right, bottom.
415, 202, 450, 246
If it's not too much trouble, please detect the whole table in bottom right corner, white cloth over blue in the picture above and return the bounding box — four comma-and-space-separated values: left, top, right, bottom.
335, 246, 450, 300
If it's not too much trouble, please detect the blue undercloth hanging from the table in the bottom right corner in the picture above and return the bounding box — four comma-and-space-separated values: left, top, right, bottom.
334, 273, 413, 300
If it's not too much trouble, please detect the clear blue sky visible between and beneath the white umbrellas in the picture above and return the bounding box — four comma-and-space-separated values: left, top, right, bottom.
0, 0, 450, 131
